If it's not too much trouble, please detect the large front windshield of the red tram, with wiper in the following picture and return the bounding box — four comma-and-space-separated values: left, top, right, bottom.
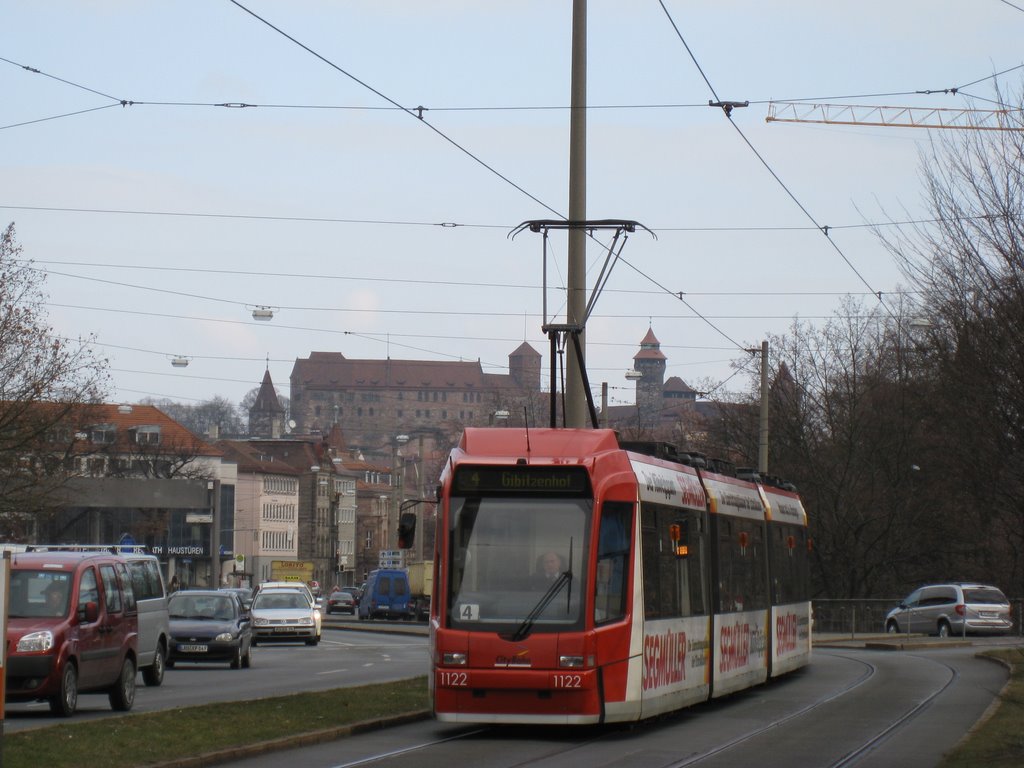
447, 497, 592, 633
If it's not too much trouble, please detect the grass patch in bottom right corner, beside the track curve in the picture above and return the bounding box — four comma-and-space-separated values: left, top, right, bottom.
940, 648, 1024, 768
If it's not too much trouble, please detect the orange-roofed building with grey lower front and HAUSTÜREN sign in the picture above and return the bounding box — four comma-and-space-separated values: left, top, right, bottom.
33, 403, 237, 586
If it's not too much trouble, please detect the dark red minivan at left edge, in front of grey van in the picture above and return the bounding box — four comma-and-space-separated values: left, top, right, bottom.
6, 551, 138, 717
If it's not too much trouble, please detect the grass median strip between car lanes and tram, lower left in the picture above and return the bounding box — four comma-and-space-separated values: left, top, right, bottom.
0, 677, 430, 768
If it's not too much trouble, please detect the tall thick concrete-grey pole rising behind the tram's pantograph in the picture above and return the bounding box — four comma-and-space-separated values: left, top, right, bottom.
565, 0, 587, 428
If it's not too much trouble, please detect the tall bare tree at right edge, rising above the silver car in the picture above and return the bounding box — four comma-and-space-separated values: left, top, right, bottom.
879, 91, 1024, 588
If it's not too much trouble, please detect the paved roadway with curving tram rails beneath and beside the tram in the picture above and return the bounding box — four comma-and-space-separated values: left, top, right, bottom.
211, 645, 1007, 768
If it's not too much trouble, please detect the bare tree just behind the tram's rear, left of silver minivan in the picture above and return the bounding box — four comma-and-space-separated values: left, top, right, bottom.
734, 300, 929, 597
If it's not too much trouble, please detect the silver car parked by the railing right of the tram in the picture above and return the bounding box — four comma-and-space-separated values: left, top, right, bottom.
886, 583, 1014, 637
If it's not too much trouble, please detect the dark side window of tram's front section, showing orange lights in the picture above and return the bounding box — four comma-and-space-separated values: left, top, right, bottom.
640, 505, 708, 620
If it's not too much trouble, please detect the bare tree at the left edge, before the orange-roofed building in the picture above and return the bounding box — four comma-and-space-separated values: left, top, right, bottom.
0, 224, 108, 536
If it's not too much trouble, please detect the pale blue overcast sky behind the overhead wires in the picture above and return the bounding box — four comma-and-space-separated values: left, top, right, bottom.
0, 0, 1024, 415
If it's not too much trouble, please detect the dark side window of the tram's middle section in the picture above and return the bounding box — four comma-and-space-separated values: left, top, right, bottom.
718, 516, 768, 612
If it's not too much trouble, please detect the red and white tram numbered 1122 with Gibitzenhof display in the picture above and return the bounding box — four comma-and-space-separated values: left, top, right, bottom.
430, 428, 811, 724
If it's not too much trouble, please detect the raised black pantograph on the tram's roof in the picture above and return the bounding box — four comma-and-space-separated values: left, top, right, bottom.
509, 219, 657, 429
